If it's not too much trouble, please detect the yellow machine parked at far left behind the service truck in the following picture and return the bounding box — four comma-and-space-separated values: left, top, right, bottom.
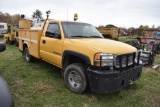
4, 25, 19, 46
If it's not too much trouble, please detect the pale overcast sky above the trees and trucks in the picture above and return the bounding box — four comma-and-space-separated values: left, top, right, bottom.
0, 0, 160, 28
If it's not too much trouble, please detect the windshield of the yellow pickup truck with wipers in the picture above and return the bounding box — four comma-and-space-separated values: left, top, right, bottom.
62, 22, 103, 38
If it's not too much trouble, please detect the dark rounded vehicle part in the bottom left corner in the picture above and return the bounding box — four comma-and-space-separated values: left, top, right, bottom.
0, 77, 14, 107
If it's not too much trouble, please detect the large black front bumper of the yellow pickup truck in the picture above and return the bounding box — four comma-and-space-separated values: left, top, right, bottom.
87, 65, 142, 93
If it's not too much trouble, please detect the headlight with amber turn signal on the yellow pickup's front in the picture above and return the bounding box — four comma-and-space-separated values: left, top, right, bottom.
94, 53, 114, 66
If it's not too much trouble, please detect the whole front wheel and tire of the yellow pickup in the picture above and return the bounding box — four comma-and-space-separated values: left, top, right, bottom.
64, 63, 87, 94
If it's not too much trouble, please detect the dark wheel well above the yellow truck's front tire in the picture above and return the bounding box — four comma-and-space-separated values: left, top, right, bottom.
62, 55, 86, 71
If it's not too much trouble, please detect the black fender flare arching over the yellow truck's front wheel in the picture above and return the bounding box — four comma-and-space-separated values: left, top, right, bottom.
62, 50, 91, 65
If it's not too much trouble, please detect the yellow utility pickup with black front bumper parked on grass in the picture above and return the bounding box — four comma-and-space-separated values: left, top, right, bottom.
18, 11, 142, 94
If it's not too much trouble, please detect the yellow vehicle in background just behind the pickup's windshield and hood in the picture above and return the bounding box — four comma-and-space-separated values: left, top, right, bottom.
97, 26, 118, 40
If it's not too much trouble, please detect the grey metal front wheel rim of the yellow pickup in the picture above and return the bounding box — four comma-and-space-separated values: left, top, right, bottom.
68, 71, 81, 89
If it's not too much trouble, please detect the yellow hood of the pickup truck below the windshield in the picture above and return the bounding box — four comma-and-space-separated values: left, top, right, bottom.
70, 38, 137, 55
